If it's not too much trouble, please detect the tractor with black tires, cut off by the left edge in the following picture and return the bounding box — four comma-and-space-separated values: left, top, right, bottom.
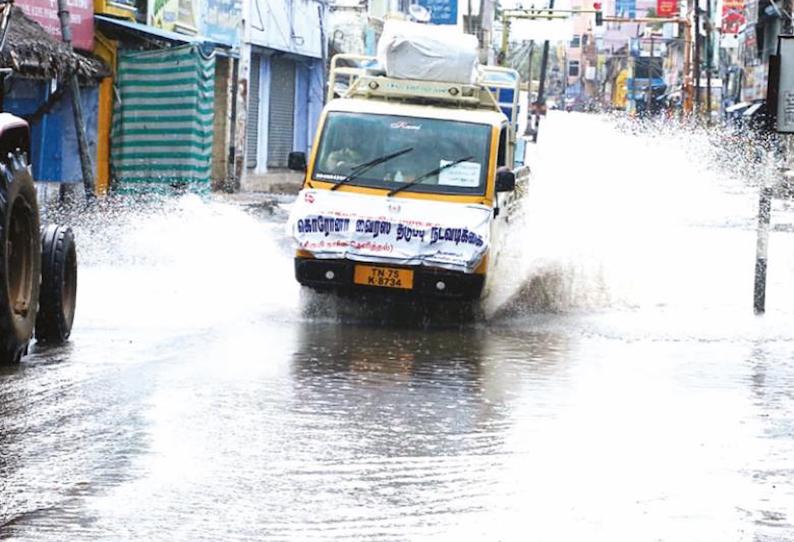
0, 2, 77, 363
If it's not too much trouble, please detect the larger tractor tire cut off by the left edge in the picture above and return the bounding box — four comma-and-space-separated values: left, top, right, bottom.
0, 152, 41, 364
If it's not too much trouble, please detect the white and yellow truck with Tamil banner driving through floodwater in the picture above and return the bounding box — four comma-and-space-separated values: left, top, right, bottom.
288, 23, 529, 300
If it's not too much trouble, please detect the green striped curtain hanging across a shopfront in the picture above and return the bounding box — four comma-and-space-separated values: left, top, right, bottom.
111, 45, 215, 192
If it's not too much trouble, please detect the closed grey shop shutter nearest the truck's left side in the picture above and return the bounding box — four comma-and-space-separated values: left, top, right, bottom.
267, 57, 295, 168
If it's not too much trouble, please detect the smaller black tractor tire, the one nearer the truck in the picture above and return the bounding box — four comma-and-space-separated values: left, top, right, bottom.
36, 226, 77, 344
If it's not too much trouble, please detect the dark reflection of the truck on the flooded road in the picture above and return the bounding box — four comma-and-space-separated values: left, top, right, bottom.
293, 323, 488, 457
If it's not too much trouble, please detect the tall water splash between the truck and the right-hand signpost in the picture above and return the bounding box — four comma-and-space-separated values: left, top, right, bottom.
486, 113, 774, 316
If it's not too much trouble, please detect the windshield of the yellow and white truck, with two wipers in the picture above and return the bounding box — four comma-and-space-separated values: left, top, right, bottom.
312, 112, 491, 195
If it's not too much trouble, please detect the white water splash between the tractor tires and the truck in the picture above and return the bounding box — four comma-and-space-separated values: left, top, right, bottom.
48, 196, 298, 333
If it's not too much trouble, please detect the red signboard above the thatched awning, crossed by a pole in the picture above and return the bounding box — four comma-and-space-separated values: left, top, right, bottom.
16, 0, 94, 51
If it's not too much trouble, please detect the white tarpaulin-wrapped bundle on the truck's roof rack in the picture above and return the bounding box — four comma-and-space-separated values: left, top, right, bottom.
378, 20, 479, 84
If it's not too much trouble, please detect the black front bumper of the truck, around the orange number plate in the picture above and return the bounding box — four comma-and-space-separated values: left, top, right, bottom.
295, 257, 485, 300
